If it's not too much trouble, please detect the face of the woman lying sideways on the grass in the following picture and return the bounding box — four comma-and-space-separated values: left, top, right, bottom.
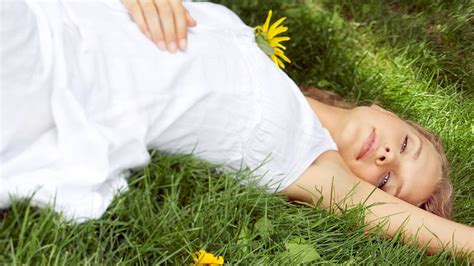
338, 105, 441, 205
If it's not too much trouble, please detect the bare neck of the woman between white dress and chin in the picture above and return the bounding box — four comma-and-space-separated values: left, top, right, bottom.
306, 97, 350, 147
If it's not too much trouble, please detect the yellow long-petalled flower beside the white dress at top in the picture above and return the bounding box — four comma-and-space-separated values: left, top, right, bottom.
255, 10, 291, 68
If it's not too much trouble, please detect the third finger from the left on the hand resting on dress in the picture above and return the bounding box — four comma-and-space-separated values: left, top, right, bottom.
155, 0, 178, 53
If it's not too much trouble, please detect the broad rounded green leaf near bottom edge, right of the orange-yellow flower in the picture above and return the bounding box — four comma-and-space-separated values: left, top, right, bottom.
285, 238, 321, 263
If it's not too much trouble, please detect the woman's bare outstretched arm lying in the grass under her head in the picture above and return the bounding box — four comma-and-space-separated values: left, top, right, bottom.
282, 151, 474, 254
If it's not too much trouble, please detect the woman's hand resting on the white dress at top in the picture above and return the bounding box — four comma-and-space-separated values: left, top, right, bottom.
122, 0, 196, 53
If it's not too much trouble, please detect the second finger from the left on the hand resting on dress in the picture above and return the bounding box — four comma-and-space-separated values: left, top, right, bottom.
139, 0, 166, 50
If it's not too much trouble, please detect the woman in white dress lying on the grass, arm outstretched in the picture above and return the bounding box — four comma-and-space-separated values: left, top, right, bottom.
0, 1, 474, 260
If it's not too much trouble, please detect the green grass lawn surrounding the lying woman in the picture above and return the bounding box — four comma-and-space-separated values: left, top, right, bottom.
0, 0, 474, 265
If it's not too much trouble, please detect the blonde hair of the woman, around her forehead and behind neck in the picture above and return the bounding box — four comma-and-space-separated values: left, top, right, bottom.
300, 86, 453, 219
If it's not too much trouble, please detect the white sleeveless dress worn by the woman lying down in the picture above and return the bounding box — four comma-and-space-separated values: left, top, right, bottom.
0, 0, 336, 221
